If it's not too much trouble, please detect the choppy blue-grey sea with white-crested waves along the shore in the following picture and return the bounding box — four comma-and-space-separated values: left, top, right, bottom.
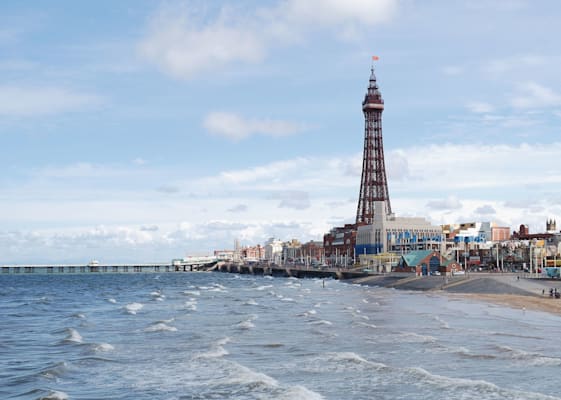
0, 272, 561, 400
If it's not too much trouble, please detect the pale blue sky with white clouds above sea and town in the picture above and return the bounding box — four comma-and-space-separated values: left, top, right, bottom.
0, 0, 561, 264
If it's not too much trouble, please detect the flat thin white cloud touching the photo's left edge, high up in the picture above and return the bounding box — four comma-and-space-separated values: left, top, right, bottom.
0, 86, 102, 117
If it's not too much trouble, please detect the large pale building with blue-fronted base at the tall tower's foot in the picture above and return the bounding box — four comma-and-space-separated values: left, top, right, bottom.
355, 201, 444, 263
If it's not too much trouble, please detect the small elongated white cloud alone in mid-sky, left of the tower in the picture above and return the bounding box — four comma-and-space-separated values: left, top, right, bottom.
203, 112, 305, 140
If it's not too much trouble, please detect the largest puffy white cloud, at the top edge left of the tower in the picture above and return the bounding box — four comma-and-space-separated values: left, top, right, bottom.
139, 0, 397, 79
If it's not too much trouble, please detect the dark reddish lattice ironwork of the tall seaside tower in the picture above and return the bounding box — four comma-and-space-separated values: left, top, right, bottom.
356, 67, 392, 224
